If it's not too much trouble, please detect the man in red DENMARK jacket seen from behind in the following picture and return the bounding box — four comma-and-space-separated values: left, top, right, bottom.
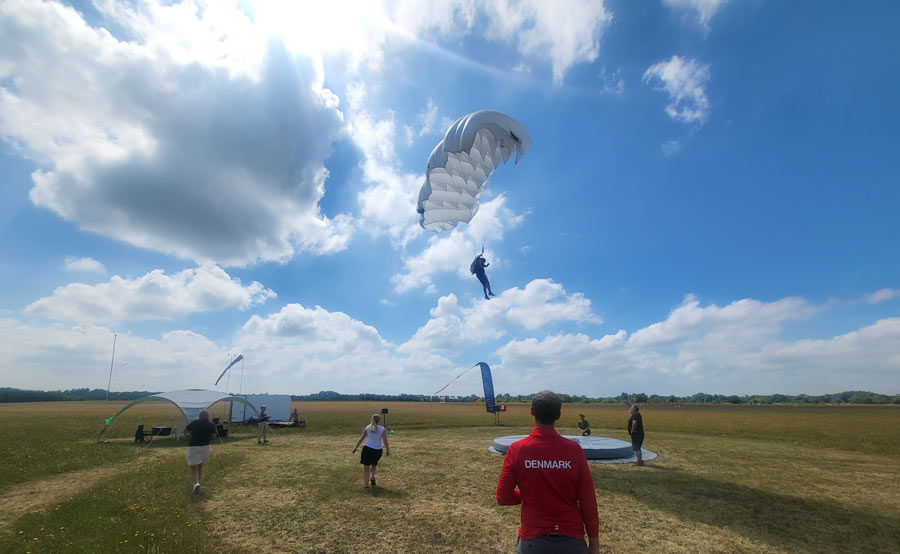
497, 391, 600, 554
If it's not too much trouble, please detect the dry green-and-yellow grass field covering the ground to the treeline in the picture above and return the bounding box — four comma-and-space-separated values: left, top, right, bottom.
0, 402, 900, 554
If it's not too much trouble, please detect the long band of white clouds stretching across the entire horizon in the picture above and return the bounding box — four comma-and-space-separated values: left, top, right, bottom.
0, 292, 900, 396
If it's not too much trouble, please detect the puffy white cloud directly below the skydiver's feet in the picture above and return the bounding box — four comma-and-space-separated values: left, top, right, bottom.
398, 279, 600, 352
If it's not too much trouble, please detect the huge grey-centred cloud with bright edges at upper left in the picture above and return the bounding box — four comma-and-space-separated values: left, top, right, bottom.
0, 0, 352, 265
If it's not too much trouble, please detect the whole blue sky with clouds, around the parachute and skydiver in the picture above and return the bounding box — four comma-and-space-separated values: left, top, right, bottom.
0, 0, 900, 396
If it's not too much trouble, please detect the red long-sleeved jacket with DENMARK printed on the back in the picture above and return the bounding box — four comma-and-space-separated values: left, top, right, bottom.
497, 427, 600, 540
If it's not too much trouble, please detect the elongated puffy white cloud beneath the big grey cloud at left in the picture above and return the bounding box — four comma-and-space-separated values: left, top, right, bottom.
25, 265, 275, 323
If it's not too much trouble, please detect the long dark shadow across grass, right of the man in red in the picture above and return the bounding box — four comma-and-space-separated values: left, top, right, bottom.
594, 465, 900, 552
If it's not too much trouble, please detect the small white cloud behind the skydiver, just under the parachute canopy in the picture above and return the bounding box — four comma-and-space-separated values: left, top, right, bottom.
391, 194, 525, 293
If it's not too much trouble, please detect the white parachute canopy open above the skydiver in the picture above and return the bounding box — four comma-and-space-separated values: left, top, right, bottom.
416, 110, 531, 232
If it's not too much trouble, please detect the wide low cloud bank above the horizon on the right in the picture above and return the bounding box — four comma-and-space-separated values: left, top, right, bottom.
497, 295, 900, 394
